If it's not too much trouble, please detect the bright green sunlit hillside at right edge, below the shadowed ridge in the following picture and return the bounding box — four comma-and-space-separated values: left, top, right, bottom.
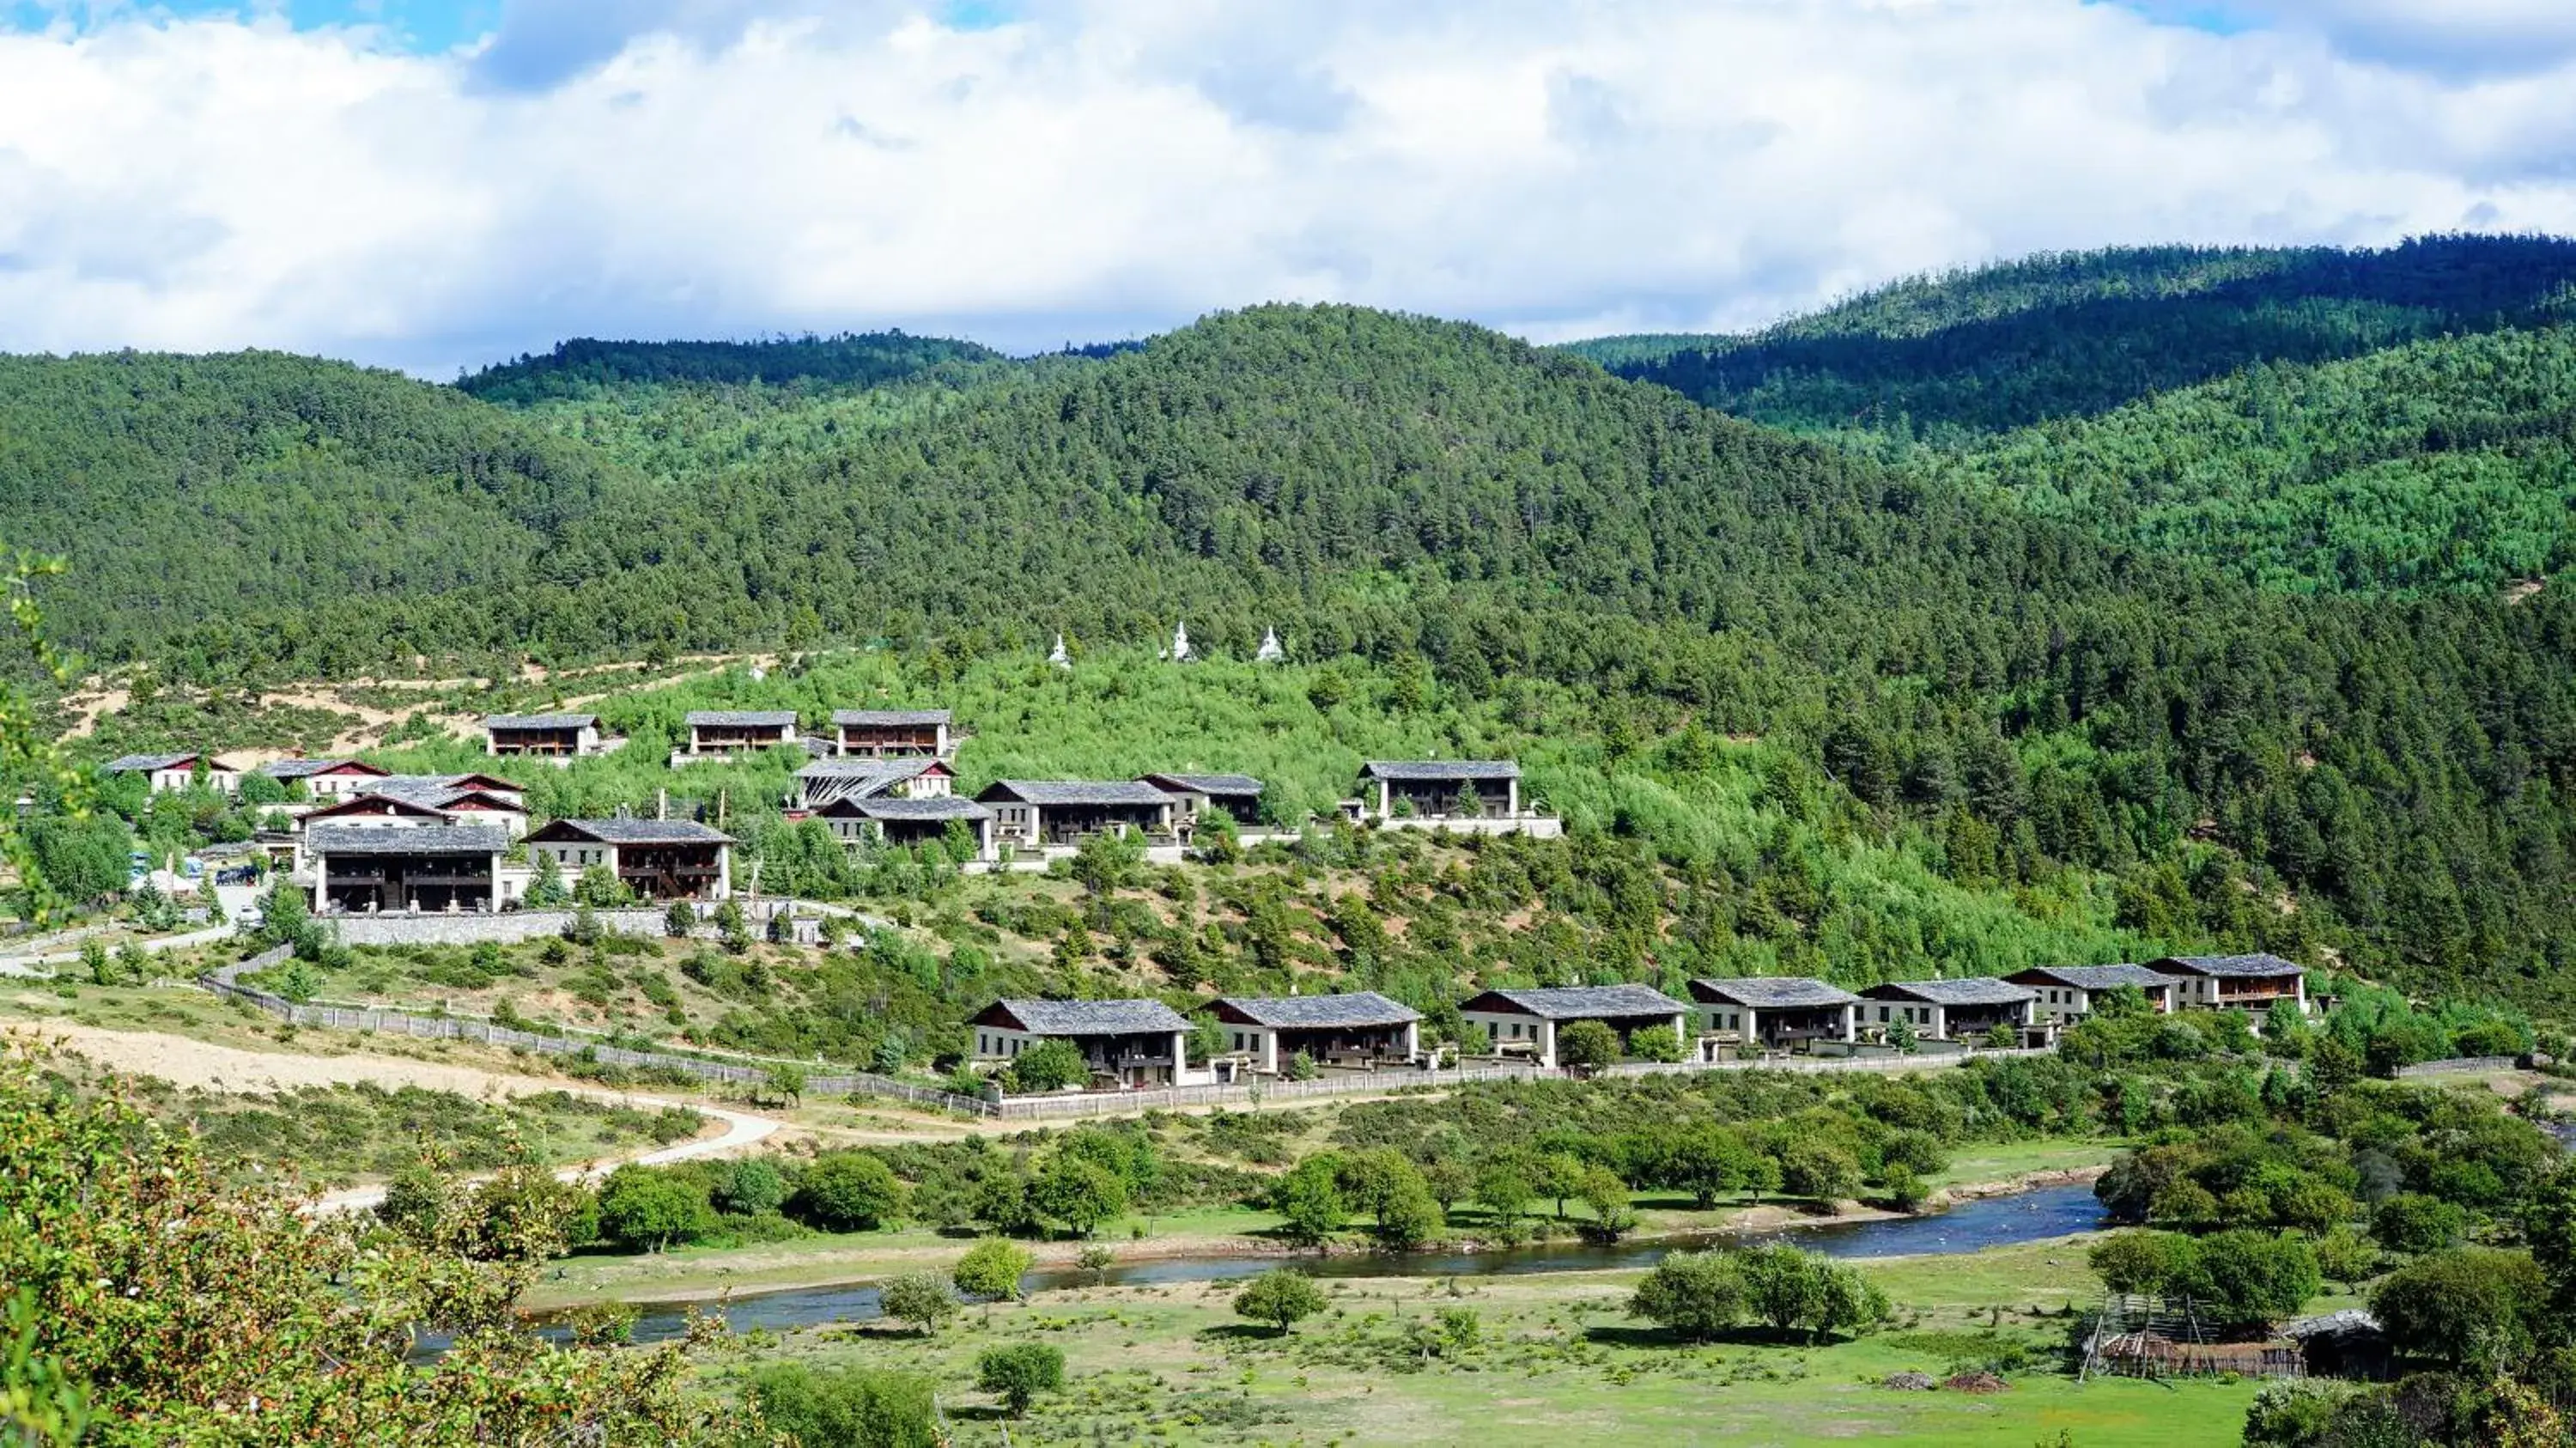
1919, 327, 2576, 593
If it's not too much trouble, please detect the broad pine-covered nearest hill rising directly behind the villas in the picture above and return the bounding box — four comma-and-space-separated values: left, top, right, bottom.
15, 307, 2576, 995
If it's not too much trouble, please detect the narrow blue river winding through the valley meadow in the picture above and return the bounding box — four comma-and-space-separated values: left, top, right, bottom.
592, 1183, 2102, 1342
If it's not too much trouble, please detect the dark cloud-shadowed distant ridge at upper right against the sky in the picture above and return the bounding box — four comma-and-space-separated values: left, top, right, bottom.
1571, 237, 2576, 446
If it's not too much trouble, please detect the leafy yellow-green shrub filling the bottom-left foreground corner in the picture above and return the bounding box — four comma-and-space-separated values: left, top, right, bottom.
0, 1046, 760, 1448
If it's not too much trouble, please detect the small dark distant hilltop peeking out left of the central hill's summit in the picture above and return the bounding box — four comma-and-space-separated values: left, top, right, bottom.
456, 332, 1002, 407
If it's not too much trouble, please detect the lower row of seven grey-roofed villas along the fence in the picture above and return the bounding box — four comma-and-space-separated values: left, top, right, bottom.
969, 956, 2308, 1087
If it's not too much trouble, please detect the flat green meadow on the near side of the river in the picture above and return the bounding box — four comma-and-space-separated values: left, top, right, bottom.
742, 1239, 2254, 1448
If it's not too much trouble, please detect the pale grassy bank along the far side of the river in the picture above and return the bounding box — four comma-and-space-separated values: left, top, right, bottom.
520, 1141, 2117, 1311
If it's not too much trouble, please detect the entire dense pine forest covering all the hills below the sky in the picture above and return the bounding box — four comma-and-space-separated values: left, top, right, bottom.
15, 240, 2576, 1000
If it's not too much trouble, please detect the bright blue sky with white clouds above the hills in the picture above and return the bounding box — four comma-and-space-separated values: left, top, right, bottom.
0, 0, 2576, 379
